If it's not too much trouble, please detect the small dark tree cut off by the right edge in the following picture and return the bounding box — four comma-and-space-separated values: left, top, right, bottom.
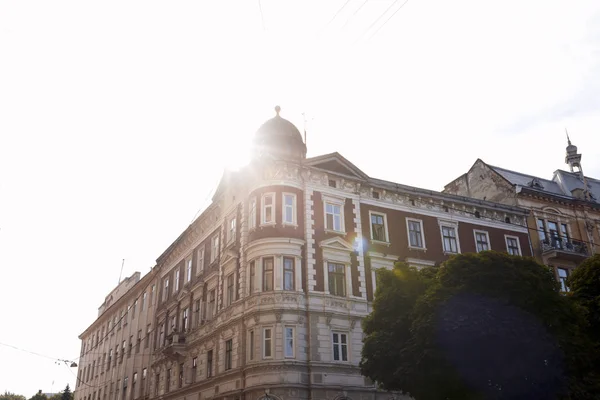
567, 254, 600, 342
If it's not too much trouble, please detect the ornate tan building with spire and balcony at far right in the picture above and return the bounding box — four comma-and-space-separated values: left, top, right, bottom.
444, 135, 600, 291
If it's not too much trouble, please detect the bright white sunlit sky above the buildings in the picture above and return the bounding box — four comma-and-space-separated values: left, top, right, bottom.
0, 0, 600, 397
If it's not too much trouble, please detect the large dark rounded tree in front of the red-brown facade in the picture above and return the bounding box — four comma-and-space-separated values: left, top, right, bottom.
361, 252, 597, 400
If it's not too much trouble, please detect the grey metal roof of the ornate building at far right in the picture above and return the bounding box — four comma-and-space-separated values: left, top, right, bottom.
488, 164, 600, 202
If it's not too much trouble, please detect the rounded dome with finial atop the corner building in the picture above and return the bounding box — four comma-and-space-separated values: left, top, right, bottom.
253, 106, 306, 161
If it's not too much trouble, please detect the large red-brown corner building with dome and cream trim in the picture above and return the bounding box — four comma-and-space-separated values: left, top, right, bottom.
78, 108, 531, 400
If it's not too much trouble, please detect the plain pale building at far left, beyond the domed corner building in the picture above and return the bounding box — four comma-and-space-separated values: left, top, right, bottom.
74, 272, 156, 400
